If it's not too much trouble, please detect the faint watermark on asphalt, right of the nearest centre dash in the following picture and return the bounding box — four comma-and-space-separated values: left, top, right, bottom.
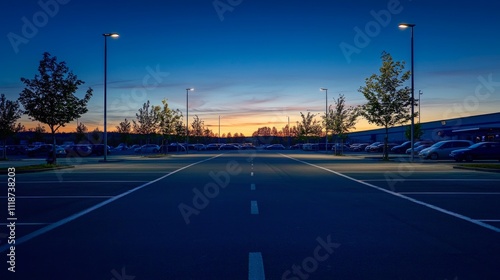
281, 235, 340, 280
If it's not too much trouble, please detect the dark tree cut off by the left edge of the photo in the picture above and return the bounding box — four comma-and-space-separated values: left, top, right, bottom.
0, 94, 23, 159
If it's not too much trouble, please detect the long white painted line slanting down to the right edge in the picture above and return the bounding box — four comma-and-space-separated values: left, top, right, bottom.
280, 154, 500, 233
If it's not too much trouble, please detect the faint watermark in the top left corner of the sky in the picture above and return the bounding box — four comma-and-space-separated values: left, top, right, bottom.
7, 0, 71, 54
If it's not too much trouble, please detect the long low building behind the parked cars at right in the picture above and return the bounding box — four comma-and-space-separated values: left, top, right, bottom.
348, 113, 500, 143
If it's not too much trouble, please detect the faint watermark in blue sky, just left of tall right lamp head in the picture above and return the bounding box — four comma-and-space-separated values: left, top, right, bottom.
339, 0, 403, 63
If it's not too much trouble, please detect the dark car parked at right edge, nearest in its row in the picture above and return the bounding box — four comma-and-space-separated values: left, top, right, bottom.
450, 142, 500, 161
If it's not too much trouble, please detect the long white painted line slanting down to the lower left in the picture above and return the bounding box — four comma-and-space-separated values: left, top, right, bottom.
0, 154, 222, 252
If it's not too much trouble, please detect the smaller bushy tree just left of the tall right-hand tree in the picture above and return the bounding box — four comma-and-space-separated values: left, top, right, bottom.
326, 94, 359, 154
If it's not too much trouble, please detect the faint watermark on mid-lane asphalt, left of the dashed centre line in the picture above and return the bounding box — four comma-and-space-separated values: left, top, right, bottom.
178, 160, 243, 225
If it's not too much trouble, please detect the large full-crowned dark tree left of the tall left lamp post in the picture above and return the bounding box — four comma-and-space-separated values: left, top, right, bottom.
19, 52, 92, 163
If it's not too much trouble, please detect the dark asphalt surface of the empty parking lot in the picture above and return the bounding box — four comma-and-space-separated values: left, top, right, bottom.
0, 152, 500, 280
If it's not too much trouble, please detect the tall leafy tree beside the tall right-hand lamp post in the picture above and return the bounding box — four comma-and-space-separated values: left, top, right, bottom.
358, 52, 412, 160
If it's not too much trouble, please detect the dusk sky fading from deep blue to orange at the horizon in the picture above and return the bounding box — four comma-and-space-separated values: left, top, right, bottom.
0, 0, 500, 135
